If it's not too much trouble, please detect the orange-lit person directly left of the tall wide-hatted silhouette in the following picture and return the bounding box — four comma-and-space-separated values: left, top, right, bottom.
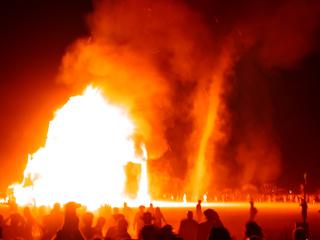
41, 203, 64, 240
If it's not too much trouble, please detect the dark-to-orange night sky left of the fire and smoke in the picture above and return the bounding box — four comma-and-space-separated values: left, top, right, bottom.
0, 0, 92, 188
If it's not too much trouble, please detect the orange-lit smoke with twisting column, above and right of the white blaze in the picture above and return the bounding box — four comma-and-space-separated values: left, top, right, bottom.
58, 0, 319, 200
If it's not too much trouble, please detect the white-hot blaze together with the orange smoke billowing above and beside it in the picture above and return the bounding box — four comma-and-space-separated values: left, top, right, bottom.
6, 0, 320, 208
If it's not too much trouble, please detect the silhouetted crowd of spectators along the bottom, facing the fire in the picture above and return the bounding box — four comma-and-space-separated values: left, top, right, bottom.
0, 200, 308, 240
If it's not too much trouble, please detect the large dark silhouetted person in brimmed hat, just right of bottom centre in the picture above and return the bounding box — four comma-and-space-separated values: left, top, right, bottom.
196, 209, 224, 240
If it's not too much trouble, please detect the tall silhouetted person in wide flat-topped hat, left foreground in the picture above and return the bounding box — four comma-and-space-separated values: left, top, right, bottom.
55, 202, 84, 240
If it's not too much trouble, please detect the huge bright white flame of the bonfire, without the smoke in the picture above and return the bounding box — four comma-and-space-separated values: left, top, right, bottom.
14, 87, 150, 209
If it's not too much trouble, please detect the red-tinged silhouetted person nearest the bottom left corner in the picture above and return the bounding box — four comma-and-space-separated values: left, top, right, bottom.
3, 213, 33, 240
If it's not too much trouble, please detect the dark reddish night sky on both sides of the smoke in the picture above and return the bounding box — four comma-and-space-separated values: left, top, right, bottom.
0, 0, 320, 193
